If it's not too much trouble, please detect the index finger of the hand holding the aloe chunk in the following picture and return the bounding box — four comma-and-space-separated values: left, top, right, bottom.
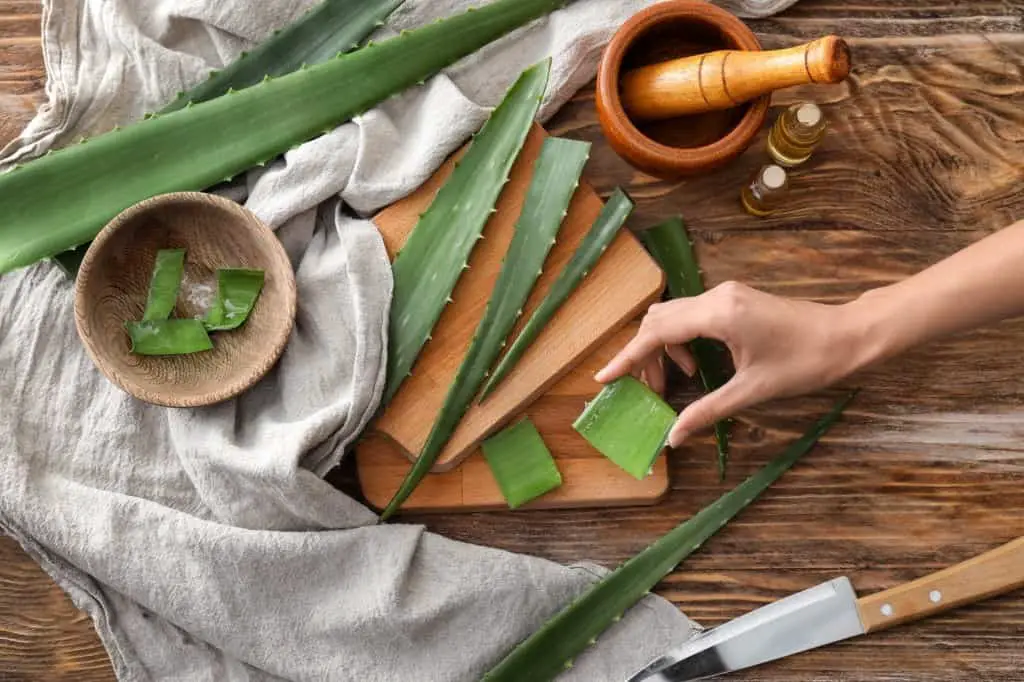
594, 297, 710, 383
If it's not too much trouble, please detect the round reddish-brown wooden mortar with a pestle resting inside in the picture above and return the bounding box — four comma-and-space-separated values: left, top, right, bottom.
596, 0, 771, 179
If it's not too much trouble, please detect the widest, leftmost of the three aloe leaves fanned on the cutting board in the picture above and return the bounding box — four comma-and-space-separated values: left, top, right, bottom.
384, 58, 551, 403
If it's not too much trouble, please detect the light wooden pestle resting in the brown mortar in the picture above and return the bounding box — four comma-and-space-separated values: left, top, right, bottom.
620, 36, 850, 121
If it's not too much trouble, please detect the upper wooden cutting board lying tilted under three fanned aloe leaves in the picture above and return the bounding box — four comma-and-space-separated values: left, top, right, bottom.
371, 125, 665, 471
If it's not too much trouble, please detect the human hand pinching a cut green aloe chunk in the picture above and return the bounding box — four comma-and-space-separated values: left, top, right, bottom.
595, 282, 865, 447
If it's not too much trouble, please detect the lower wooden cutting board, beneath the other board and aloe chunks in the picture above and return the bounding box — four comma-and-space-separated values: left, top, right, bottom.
355, 323, 669, 512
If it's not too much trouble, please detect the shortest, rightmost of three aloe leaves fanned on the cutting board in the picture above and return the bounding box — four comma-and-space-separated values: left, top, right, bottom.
480, 188, 633, 400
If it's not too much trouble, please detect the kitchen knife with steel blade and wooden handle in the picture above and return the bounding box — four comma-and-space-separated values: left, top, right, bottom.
628, 538, 1024, 682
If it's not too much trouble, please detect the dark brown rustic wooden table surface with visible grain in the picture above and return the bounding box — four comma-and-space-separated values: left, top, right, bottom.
0, 0, 1024, 682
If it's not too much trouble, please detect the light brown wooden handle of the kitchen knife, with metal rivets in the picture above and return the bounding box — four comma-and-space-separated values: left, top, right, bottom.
857, 538, 1024, 632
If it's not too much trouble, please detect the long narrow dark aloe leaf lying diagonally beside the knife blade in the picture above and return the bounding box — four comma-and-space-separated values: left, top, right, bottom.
483, 387, 854, 682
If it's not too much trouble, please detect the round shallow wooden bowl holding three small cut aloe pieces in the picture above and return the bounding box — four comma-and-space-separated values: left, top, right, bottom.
75, 188, 296, 408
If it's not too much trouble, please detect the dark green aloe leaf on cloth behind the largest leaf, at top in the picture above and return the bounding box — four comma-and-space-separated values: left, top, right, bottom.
160, 0, 404, 114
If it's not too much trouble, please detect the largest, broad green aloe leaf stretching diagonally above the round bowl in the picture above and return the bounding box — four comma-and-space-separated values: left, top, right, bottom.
0, 0, 565, 274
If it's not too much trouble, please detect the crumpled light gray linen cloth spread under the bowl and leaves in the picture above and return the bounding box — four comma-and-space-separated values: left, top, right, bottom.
0, 0, 795, 682
